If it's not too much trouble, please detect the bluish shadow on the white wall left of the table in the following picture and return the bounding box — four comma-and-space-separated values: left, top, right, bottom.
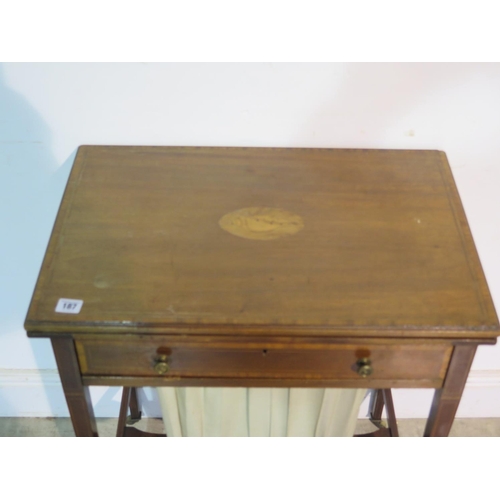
0, 65, 76, 415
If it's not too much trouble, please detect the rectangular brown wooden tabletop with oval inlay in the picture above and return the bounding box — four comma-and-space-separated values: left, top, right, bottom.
25, 146, 499, 338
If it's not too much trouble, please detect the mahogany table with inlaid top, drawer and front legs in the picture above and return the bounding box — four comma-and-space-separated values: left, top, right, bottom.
25, 146, 500, 436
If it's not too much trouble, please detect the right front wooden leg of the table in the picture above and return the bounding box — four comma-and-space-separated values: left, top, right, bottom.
424, 344, 477, 437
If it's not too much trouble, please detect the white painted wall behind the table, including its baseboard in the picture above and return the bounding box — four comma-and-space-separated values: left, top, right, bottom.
0, 63, 500, 417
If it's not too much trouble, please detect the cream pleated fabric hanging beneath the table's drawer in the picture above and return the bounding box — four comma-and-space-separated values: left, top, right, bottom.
158, 387, 366, 437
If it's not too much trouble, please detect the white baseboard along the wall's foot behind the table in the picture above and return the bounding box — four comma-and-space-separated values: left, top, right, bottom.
0, 369, 500, 419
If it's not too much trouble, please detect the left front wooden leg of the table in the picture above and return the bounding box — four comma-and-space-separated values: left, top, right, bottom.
52, 337, 97, 437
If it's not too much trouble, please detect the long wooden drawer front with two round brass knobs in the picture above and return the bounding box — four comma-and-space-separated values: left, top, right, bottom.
75, 336, 453, 387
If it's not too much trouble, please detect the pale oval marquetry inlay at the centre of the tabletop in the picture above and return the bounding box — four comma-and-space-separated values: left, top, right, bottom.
219, 207, 304, 240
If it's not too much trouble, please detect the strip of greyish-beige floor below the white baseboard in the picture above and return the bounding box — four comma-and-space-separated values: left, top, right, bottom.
0, 417, 500, 437
